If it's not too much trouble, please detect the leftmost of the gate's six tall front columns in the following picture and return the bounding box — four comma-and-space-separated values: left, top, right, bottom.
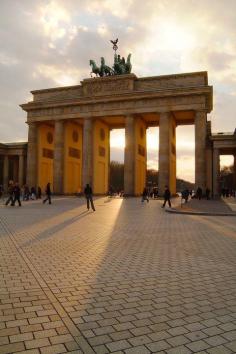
26, 123, 38, 188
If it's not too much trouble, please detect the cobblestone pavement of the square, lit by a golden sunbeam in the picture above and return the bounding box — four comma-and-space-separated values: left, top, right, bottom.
0, 198, 236, 354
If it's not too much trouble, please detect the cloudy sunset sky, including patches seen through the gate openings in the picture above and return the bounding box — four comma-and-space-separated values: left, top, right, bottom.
0, 0, 236, 181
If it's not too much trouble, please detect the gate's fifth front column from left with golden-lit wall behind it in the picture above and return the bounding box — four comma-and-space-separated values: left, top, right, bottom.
158, 112, 176, 195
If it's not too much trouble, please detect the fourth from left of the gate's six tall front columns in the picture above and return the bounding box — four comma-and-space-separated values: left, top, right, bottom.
124, 115, 135, 196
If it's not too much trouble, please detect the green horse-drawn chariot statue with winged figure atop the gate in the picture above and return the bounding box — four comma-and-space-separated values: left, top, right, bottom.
89, 38, 132, 77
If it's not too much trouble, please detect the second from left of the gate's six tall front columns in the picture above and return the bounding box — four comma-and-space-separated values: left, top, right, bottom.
53, 120, 64, 194
